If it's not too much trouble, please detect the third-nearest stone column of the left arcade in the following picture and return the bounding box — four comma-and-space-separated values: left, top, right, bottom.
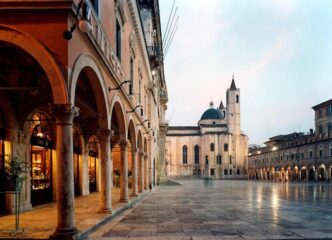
120, 140, 129, 202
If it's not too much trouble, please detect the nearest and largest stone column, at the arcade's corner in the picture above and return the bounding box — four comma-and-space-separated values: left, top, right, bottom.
50, 104, 78, 239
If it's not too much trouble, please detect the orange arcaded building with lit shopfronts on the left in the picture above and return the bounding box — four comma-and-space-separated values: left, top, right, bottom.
0, 0, 167, 239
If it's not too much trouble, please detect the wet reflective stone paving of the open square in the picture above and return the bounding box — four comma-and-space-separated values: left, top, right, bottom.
90, 180, 332, 240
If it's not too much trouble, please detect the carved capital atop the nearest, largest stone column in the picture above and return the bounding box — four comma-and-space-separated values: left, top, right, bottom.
49, 103, 79, 125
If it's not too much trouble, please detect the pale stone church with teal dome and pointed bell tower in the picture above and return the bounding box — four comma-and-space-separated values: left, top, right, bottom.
165, 78, 248, 179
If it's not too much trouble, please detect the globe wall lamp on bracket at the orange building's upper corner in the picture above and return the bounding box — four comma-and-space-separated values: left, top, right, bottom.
63, 0, 92, 41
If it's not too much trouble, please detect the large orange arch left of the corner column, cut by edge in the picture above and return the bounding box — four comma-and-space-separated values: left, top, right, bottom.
0, 25, 69, 104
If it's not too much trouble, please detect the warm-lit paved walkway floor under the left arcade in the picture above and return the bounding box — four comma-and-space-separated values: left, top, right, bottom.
0, 189, 146, 239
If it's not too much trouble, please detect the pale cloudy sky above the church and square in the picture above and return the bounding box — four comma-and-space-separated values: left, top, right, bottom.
160, 0, 332, 144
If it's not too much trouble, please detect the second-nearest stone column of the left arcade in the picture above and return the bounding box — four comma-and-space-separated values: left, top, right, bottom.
99, 129, 113, 213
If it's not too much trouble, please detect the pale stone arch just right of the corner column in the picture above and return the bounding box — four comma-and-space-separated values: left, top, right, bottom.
69, 53, 110, 129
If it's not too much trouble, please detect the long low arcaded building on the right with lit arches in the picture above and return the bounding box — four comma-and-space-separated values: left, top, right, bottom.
248, 99, 332, 181
